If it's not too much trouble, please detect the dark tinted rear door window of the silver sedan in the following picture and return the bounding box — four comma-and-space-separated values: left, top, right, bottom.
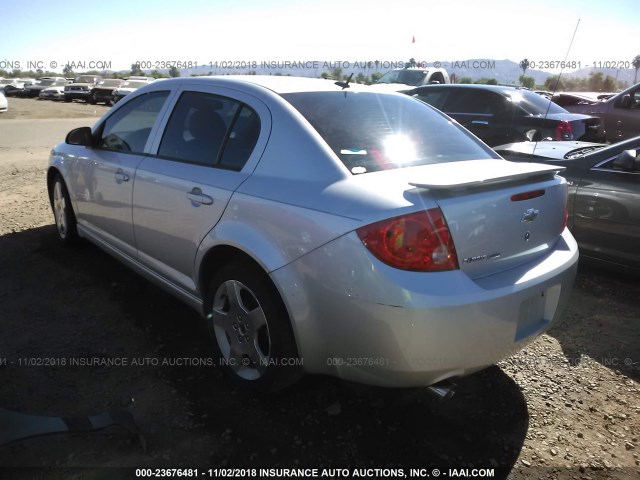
158, 92, 260, 170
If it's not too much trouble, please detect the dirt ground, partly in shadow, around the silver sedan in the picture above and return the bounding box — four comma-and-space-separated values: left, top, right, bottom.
0, 99, 640, 479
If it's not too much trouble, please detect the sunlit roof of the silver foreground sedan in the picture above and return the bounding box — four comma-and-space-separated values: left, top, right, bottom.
154, 75, 373, 94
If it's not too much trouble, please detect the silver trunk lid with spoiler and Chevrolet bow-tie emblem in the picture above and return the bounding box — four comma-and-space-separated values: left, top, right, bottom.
409, 160, 567, 278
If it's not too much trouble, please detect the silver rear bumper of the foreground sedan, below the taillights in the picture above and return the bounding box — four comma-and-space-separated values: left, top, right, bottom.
272, 230, 578, 387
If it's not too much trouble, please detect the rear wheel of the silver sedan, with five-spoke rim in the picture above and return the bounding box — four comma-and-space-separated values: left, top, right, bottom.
206, 262, 302, 392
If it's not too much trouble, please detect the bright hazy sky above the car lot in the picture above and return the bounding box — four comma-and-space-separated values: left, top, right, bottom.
0, 0, 640, 72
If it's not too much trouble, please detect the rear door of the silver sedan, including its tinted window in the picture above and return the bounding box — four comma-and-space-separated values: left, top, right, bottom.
133, 87, 270, 293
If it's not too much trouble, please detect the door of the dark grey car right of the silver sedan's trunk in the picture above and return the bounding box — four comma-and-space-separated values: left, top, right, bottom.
573, 153, 640, 267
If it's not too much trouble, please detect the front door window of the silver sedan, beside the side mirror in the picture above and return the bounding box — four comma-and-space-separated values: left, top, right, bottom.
98, 91, 169, 154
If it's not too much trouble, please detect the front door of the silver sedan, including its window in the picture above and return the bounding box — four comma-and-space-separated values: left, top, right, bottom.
71, 90, 169, 258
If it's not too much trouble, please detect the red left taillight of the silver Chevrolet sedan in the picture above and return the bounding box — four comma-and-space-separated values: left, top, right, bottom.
357, 208, 458, 272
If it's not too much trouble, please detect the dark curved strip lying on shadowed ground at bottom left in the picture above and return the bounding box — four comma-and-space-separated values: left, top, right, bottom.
0, 408, 147, 451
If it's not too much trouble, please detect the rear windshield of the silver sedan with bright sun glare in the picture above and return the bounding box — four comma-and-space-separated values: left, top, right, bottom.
282, 92, 498, 174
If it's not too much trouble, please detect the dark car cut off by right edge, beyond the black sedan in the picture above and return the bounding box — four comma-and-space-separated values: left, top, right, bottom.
566, 83, 640, 142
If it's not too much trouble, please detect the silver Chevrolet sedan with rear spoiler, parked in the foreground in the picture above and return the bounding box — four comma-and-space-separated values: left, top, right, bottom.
47, 75, 578, 391
